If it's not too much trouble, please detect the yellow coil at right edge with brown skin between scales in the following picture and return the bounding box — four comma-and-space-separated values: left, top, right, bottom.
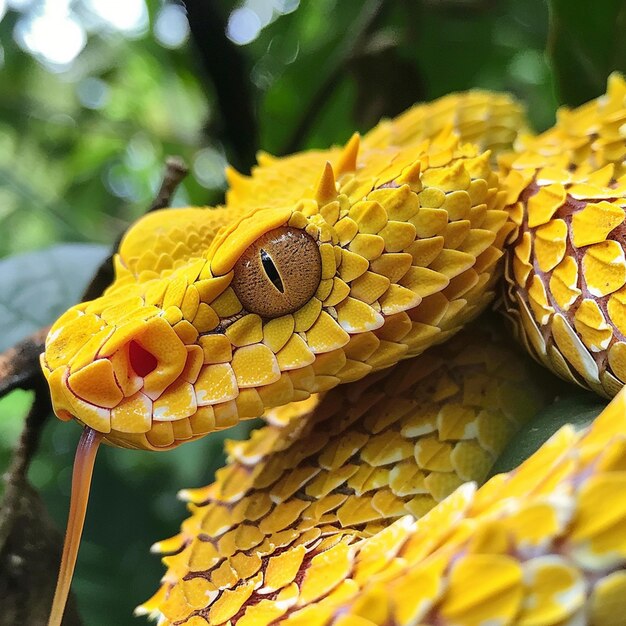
503, 74, 626, 397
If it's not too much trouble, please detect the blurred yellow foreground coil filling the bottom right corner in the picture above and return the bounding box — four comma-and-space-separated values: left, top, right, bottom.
144, 390, 626, 626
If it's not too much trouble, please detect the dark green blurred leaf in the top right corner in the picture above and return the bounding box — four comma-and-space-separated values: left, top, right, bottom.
548, 0, 626, 106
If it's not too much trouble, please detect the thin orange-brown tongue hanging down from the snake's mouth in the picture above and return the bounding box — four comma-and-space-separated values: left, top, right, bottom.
48, 427, 102, 626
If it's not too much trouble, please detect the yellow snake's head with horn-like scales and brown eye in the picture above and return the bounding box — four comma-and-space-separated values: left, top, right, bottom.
42, 119, 508, 449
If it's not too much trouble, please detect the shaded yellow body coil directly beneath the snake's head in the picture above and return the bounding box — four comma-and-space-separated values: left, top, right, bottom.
140, 327, 550, 626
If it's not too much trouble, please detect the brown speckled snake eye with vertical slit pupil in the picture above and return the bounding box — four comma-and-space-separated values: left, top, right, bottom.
232, 226, 322, 318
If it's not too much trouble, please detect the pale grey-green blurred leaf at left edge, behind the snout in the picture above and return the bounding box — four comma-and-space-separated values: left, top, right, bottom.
0, 244, 109, 351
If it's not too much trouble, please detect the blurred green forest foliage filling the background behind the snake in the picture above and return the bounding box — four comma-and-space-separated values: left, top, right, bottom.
0, 0, 626, 626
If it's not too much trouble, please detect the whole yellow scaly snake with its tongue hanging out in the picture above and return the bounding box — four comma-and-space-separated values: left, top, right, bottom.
42, 75, 626, 626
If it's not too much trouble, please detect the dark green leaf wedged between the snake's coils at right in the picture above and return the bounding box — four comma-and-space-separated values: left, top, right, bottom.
489, 390, 607, 478
